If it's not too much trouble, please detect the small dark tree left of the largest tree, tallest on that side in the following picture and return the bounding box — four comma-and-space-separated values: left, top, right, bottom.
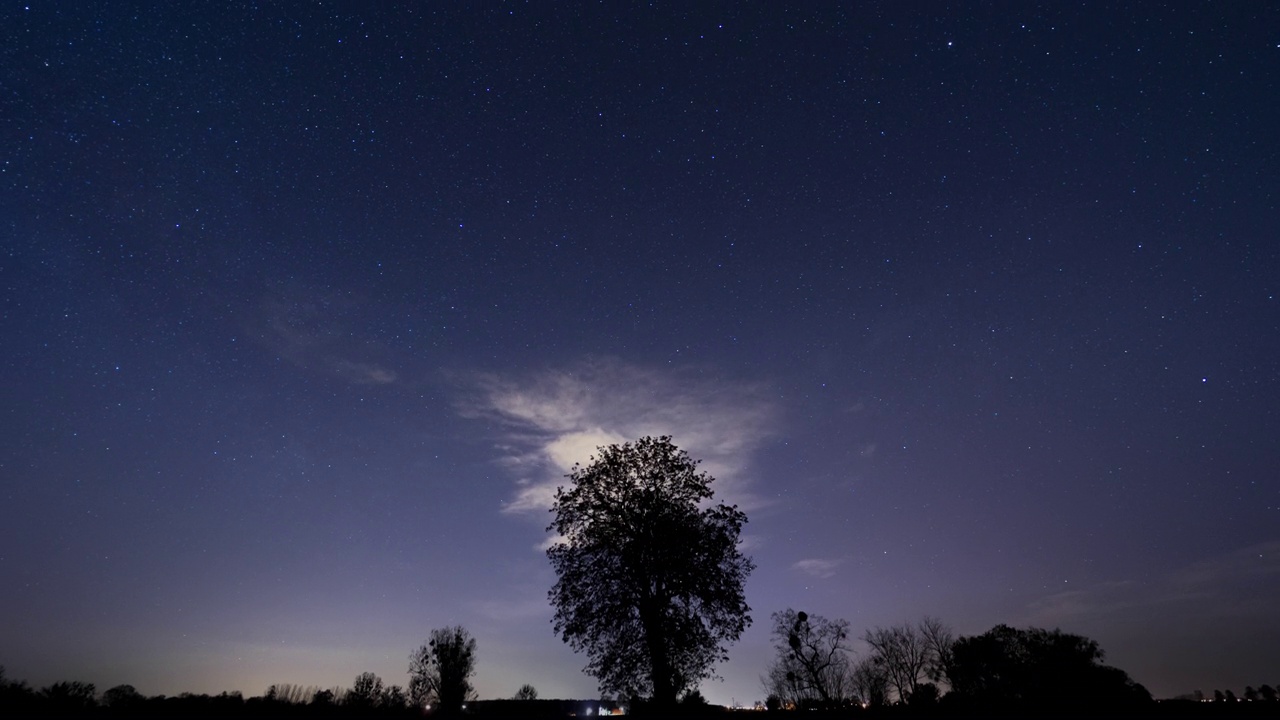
408, 625, 476, 714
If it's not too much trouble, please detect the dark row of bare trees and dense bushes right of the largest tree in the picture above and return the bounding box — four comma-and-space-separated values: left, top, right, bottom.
760, 609, 1151, 711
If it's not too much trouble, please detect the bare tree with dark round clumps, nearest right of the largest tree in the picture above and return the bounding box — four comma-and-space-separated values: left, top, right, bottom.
764, 607, 849, 707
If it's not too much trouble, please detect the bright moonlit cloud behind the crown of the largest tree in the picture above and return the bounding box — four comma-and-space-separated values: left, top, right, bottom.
460, 359, 774, 512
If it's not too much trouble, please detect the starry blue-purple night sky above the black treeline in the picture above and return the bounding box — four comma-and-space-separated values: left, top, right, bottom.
0, 0, 1280, 703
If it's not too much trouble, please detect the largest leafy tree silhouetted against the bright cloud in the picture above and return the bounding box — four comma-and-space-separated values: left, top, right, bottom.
547, 437, 754, 707
